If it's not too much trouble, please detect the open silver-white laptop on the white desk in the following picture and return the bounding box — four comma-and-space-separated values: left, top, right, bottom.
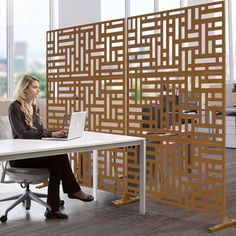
42, 111, 87, 141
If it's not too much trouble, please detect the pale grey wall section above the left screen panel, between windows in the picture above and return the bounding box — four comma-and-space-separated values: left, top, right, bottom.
58, 0, 101, 28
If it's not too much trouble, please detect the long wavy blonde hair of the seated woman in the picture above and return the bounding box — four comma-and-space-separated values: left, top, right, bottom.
13, 75, 39, 128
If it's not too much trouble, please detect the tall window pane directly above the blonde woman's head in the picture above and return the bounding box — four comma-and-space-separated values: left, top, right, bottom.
14, 0, 49, 97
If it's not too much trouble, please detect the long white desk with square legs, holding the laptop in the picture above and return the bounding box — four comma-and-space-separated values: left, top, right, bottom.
0, 131, 146, 214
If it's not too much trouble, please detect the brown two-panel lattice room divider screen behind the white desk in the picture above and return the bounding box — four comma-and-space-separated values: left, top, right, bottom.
47, 1, 226, 216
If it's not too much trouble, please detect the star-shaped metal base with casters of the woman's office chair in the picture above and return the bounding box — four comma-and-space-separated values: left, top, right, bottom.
0, 186, 51, 223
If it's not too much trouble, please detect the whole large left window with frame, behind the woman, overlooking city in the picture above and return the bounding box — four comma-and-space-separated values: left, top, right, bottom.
0, 0, 53, 99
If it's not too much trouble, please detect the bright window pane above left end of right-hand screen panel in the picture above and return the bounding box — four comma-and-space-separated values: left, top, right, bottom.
130, 0, 154, 16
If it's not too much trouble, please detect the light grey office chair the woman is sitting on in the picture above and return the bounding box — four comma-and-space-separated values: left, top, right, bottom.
0, 116, 51, 223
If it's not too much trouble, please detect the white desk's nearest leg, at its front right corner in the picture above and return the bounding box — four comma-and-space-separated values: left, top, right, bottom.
138, 141, 146, 214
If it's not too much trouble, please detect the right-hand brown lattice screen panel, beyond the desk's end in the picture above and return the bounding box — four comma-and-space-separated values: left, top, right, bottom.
127, 2, 225, 215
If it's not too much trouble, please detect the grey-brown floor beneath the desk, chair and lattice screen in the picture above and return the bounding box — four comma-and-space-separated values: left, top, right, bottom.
0, 149, 236, 236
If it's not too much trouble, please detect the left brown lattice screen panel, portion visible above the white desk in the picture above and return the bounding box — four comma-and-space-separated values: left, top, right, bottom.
47, 19, 125, 134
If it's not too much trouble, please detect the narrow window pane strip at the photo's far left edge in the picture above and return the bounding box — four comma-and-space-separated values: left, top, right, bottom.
0, 0, 7, 99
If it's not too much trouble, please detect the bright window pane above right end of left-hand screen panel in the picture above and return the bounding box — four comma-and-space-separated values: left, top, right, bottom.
101, 0, 125, 21
